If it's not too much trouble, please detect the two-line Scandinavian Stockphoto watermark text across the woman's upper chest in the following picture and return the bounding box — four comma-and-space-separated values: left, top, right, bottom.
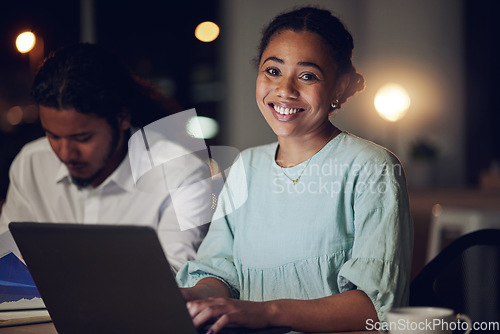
272, 159, 404, 197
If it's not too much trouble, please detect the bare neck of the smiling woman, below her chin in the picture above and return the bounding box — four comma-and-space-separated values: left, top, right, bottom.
275, 123, 341, 168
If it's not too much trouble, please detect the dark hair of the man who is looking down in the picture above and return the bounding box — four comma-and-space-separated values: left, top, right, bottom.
31, 43, 179, 127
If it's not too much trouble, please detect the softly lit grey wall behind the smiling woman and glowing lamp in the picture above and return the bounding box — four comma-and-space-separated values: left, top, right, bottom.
221, 0, 465, 186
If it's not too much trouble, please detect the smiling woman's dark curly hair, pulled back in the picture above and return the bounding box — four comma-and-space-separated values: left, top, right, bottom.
255, 7, 365, 108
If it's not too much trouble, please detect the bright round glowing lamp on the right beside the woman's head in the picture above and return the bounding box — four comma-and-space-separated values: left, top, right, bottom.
374, 83, 411, 122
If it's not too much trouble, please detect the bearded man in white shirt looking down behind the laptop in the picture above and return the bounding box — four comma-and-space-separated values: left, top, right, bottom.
0, 44, 211, 269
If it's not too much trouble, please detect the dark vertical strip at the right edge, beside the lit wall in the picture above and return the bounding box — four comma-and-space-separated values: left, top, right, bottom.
464, 0, 500, 187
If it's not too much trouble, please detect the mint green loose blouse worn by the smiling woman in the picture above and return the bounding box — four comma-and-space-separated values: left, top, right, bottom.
177, 131, 413, 320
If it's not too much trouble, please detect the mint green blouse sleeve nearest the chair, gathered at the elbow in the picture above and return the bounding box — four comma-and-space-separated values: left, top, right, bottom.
337, 153, 413, 321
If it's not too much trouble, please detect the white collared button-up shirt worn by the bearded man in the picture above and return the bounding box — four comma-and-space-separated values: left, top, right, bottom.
0, 137, 211, 270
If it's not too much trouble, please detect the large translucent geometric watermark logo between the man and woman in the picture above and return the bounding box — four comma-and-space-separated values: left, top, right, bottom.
128, 109, 248, 231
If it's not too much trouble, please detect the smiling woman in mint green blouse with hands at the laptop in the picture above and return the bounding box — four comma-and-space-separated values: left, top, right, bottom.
178, 7, 412, 333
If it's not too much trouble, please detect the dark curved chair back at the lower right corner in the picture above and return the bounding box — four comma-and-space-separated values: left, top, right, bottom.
410, 228, 500, 333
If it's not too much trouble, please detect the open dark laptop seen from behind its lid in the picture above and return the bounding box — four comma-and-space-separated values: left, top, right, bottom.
9, 222, 290, 334
